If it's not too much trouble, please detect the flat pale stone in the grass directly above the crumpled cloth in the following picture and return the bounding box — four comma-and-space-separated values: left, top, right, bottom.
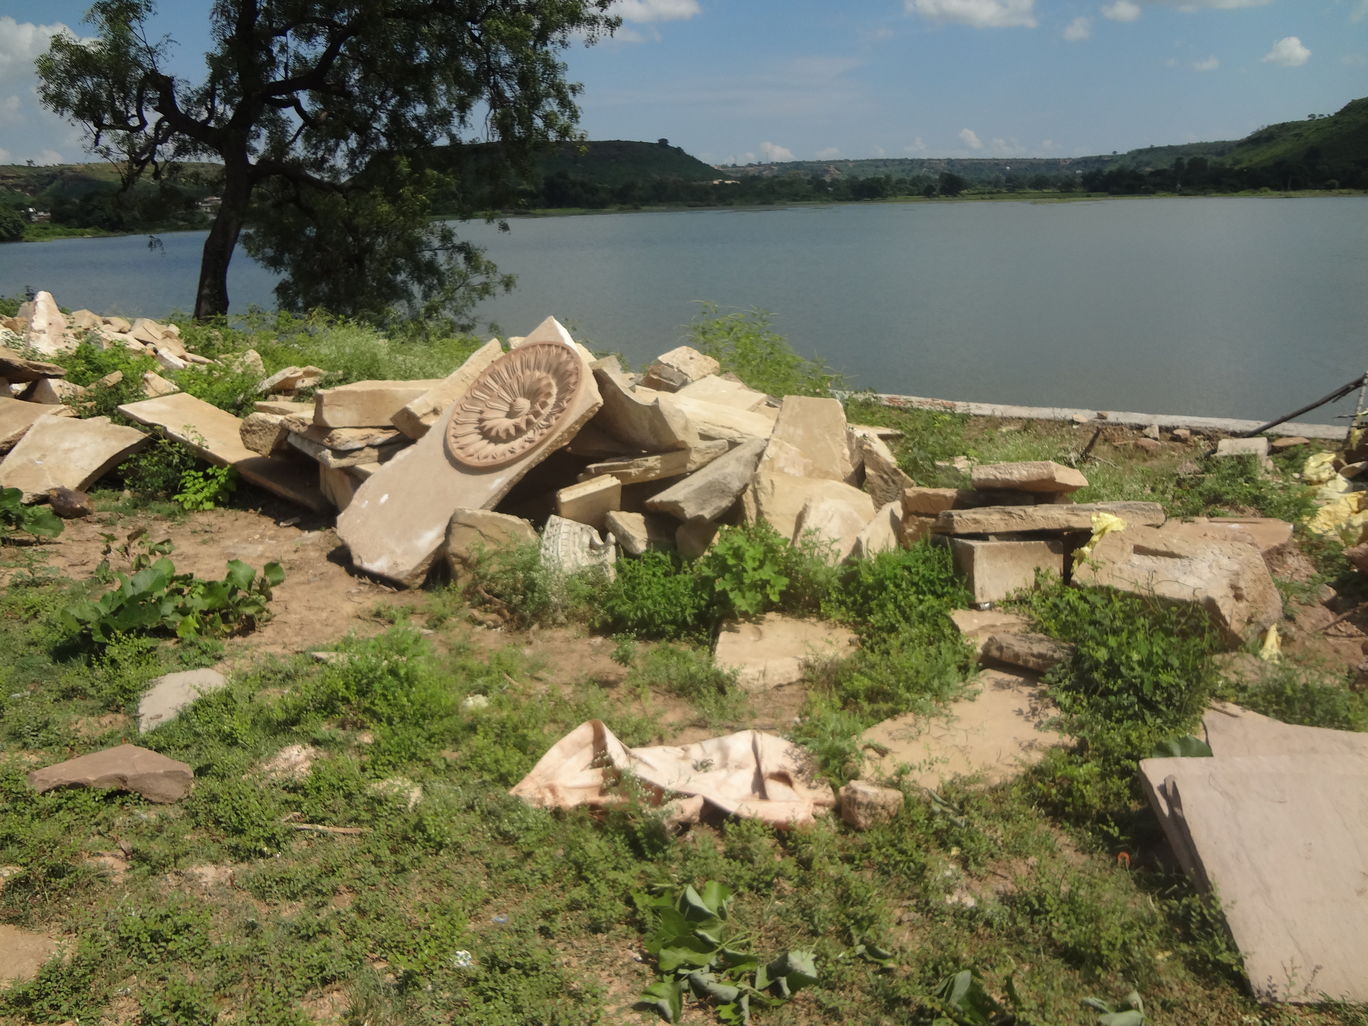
713, 613, 855, 692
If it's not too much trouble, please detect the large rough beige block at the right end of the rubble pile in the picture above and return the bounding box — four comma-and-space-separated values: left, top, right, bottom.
1077, 525, 1282, 646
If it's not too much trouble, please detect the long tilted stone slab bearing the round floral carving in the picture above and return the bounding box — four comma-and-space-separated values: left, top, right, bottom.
338, 343, 601, 587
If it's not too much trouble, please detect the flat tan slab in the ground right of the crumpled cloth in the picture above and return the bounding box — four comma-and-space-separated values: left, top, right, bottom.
862, 670, 1064, 789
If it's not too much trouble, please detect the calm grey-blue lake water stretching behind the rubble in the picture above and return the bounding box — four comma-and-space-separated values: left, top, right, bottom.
0, 197, 1368, 421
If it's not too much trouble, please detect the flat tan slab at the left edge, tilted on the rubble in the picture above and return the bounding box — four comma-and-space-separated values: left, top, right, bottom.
0, 417, 148, 502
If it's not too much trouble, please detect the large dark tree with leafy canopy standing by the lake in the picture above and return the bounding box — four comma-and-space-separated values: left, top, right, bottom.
38, 0, 617, 319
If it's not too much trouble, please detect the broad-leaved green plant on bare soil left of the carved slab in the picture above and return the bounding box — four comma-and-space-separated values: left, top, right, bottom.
62, 543, 285, 646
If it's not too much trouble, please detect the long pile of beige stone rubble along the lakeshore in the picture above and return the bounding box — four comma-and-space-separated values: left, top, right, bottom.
0, 293, 1291, 659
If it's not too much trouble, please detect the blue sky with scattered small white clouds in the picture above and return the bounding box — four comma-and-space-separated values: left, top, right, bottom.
0, 0, 1368, 163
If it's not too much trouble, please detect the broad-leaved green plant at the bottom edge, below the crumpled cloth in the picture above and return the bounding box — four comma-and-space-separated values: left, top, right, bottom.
632, 880, 817, 1023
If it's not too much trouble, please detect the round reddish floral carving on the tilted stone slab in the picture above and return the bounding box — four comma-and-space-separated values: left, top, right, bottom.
446, 342, 584, 469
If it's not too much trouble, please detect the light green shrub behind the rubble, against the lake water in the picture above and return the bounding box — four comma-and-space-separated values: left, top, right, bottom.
688, 304, 844, 395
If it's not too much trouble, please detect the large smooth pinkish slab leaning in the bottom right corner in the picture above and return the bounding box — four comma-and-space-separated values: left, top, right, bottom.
1140, 755, 1368, 1003
